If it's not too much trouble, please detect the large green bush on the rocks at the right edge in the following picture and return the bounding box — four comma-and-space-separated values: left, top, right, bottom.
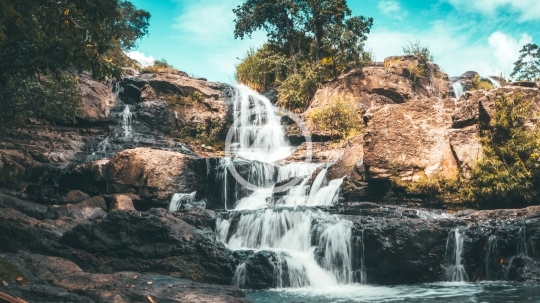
465, 95, 540, 207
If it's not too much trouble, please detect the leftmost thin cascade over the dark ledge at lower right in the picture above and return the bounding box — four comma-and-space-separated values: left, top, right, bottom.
444, 228, 469, 282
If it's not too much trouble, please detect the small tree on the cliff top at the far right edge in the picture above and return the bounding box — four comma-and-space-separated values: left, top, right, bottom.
510, 43, 540, 81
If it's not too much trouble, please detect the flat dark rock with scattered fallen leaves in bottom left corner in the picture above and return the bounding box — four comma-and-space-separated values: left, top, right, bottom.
0, 253, 250, 303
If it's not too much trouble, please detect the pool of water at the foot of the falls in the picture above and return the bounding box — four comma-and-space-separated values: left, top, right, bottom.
247, 282, 540, 303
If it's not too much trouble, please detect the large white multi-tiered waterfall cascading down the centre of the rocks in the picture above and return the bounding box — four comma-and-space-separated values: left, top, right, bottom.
216, 86, 358, 288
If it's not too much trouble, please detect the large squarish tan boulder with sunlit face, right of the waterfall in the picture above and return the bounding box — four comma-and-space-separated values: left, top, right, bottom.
364, 98, 458, 181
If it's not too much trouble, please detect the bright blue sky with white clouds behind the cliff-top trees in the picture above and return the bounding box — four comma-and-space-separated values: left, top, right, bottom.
131, 0, 540, 83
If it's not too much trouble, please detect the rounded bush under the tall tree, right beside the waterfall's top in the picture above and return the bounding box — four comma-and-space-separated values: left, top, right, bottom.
277, 66, 320, 112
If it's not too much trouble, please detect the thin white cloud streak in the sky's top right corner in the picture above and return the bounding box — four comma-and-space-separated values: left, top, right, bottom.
446, 0, 540, 22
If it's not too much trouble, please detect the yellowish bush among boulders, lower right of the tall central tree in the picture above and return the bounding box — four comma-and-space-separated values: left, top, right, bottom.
308, 96, 364, 140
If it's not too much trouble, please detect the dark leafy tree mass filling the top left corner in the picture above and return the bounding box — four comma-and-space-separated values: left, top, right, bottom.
0, 0, 150, 125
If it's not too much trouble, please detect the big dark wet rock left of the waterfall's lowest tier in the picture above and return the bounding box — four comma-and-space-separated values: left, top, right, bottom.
60, 209, 233, 284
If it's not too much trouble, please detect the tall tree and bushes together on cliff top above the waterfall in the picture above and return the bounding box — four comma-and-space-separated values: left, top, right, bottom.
233, 0, 373, 111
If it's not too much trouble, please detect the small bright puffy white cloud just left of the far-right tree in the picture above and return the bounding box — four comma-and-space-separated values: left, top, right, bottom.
488, 31, 532, 73
